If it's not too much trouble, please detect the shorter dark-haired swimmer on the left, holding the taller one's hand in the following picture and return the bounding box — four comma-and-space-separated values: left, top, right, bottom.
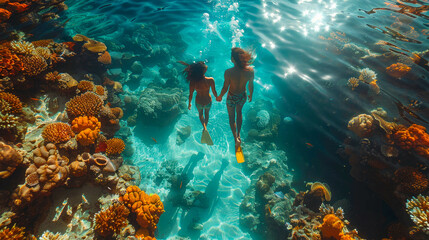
180, 62, 217, 145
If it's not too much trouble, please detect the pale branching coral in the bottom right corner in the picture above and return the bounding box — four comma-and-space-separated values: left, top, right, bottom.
405, 195, 429, 234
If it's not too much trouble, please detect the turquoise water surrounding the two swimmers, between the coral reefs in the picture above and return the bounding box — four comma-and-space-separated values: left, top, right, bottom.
3, 0, 429, 239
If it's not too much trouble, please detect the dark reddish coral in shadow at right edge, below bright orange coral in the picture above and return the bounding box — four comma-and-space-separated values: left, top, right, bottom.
395, 167, 429, 194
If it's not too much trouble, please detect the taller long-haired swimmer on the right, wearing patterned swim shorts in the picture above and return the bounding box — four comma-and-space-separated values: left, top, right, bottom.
216, 47, 254, 152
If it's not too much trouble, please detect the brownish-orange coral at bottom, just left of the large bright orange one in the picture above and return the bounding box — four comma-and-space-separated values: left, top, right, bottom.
94, 203, 130, 237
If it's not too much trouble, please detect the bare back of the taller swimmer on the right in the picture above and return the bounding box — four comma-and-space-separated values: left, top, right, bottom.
225, 67, 254, 94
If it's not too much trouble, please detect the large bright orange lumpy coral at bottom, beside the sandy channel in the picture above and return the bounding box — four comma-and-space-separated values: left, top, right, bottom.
119, 186, 164, 233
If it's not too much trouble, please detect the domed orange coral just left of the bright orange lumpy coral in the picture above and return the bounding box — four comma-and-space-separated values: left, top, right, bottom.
42, 122, 74, 143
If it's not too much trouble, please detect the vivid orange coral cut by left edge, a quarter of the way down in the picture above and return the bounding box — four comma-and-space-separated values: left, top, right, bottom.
0, 45, 24, 77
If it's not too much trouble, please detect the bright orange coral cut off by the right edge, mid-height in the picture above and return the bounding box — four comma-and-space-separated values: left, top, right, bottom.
389, 124, 429, 158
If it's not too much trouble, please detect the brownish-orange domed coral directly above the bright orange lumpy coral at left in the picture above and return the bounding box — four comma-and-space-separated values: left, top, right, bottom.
66, 92, 103, 119
